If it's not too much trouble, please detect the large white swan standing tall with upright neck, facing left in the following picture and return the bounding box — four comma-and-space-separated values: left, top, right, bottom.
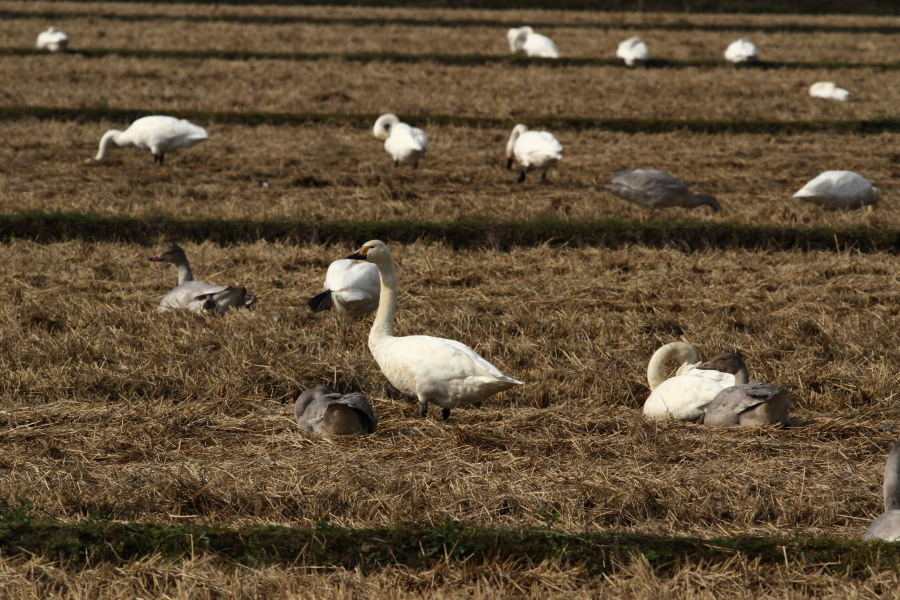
347, 240, 522, 421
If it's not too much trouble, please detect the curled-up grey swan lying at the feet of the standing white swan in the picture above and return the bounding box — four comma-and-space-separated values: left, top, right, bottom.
294, 385, 378, 436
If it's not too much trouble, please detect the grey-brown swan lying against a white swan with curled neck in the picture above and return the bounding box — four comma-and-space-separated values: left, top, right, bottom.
700, 352, 791, 427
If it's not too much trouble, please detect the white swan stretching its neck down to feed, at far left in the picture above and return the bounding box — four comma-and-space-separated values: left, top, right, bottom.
88, 115, 209, 164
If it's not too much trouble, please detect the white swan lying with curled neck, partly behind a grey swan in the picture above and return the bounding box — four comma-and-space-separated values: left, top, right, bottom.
644, 342, 734, 421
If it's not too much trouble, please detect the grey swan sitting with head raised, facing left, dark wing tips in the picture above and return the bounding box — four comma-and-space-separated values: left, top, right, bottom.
149, 244, 256, 315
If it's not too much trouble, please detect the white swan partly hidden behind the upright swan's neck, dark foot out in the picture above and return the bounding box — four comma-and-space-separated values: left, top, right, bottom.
306, 258, 381, 318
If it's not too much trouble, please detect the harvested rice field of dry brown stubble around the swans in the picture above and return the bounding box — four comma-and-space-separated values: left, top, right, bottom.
0, 1, 900, 600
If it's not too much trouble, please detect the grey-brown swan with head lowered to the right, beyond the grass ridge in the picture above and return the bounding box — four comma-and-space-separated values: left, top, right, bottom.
603, 169, 722, 212
